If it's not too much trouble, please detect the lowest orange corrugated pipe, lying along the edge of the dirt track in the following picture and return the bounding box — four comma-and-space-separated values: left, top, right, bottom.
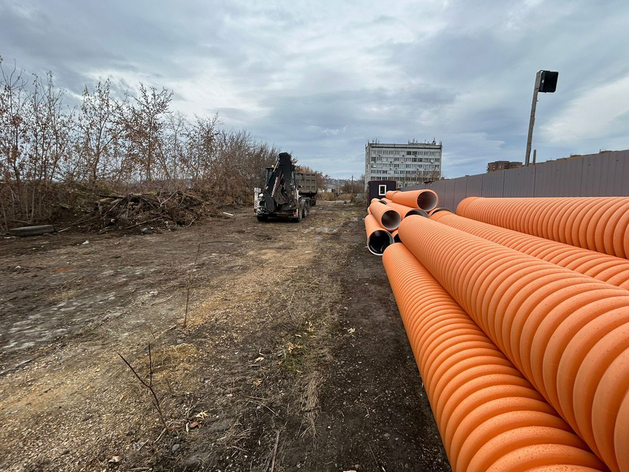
382, 243, 607, 472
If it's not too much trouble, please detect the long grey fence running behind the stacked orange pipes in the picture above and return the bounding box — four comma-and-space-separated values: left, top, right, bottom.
404, 150, 629, 210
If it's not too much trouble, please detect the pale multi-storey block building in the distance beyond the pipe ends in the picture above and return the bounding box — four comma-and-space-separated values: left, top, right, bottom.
365, 141, 442, 189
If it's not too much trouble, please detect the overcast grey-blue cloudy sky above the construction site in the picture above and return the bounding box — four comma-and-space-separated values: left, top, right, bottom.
0, 0, 629, 178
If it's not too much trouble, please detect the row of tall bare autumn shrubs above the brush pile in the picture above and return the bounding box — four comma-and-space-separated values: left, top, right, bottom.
0, 57, 278, 231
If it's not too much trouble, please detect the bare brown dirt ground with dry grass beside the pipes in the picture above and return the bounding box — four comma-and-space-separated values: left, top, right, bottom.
0, 202, 450, 472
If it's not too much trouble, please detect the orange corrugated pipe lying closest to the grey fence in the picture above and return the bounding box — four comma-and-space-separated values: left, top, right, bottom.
457, 197, 629, 258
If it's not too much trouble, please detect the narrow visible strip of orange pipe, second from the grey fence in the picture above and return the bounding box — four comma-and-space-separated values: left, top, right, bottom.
430, 210, 629, 290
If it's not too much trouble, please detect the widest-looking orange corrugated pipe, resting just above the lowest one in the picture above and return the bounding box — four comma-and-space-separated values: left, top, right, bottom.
399, 218, 629, 472
